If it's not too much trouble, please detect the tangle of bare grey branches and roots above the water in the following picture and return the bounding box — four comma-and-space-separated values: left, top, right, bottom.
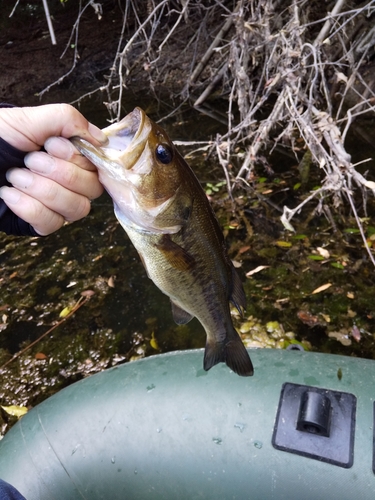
33, 0, 375, 264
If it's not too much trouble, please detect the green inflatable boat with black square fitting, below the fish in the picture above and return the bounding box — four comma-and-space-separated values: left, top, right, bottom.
0, 349, 375, 500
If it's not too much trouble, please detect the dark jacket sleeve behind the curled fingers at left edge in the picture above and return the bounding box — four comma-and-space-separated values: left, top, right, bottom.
0, 119, 40, 236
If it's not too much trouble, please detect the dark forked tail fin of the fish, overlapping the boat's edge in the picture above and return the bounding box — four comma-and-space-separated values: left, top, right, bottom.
203, 330, 254, 377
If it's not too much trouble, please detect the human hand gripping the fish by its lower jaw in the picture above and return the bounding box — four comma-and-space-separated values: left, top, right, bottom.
0, 104, 107, 235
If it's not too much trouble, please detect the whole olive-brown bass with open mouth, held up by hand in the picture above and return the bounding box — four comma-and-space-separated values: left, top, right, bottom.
70, 107, 254, 376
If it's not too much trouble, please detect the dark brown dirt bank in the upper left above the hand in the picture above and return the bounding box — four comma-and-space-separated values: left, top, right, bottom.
0, 0, 128, 106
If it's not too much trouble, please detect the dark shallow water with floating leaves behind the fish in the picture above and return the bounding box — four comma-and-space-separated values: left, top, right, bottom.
0, 101, 375, 430
